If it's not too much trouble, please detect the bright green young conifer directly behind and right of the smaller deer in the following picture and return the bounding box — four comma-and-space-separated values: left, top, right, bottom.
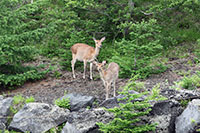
110, 19, 166, 77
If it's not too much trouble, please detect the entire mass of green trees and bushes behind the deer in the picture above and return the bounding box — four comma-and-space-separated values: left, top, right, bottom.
0, 0, 200, 87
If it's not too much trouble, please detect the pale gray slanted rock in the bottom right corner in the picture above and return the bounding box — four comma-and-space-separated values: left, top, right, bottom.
175, 99, 200, 133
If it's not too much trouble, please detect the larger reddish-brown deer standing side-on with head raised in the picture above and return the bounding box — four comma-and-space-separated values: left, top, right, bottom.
71, 37, 105, 79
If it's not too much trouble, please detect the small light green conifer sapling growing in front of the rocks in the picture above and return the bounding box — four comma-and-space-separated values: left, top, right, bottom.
98, 77, 166, 133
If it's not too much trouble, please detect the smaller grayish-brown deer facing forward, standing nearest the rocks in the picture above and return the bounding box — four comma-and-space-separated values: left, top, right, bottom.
94, 61, 119, 100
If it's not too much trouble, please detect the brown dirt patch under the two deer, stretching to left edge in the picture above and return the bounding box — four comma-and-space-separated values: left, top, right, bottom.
2, 71, 128, 104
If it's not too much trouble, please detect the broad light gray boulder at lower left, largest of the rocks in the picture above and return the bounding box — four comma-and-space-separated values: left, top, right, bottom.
9, 103, 70, 133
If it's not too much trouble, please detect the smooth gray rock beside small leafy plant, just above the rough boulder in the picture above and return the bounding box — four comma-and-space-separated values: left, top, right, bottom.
60, 93, 95, 111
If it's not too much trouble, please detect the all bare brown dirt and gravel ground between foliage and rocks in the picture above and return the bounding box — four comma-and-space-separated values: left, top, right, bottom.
1, 52, 200, 104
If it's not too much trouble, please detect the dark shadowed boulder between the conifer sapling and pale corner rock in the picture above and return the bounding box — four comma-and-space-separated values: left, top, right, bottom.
149, 100, 183, 133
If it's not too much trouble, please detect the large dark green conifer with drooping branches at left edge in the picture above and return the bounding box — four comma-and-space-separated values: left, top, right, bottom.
0, 0, 55, 88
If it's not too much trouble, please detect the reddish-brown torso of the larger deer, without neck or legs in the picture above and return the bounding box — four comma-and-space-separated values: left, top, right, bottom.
71, 43, 95, 61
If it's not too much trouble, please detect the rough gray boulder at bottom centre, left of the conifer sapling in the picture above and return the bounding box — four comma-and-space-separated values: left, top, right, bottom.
62, 108, 113, 133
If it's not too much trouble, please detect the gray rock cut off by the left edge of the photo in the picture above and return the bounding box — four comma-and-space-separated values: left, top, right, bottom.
0, 97, 13, 129
